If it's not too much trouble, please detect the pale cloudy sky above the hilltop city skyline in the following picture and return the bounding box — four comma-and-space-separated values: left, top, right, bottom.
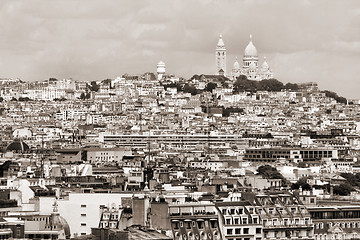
0, 0, 360, 99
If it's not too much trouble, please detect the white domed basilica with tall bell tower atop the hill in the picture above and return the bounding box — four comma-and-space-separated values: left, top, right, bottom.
215, 35, 274, 80
